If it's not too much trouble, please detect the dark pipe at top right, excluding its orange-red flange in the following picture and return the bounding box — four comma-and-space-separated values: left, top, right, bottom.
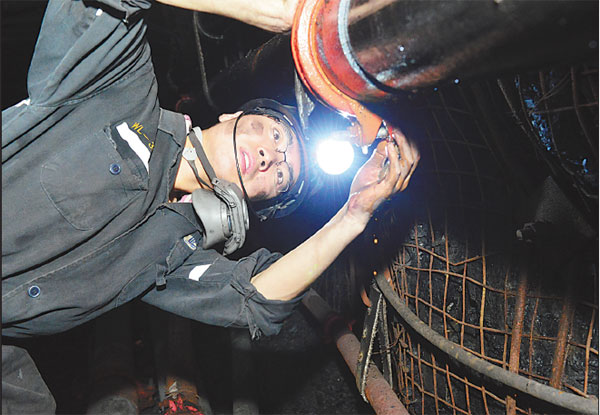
346, 0, 598, 90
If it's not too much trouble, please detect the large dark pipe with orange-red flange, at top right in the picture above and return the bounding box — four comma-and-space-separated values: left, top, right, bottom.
292, 0, 598, 145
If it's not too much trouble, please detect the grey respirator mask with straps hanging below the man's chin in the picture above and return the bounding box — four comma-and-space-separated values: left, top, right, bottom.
183, 127, 250, 255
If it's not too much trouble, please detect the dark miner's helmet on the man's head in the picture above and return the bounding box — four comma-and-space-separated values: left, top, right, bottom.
233, 98, 318, 221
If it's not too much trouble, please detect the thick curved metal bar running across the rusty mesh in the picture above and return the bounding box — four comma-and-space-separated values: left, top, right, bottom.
375, 274, 598, 415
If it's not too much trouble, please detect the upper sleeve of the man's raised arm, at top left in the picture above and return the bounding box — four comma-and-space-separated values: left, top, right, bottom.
27, 0, 151, 107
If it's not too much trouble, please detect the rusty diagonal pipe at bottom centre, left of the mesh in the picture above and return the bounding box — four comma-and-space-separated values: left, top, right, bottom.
302, 289, 409, 415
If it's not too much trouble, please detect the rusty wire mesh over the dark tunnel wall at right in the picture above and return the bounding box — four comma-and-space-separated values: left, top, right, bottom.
326, 63, 598, 414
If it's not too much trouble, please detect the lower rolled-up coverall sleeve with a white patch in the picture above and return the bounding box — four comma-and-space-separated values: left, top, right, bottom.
142, 249, 302, 338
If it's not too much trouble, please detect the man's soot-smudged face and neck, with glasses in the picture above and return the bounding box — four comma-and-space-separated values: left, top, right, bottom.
210, 114, 301, 200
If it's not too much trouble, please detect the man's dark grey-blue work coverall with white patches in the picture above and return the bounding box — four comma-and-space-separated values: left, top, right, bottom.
2, 0, 299, 413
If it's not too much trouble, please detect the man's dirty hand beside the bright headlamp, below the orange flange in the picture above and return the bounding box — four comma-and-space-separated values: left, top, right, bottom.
348, 128, 420, 225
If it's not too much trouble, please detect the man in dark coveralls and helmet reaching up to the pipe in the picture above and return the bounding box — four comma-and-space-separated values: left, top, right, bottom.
2, 0, 419, 413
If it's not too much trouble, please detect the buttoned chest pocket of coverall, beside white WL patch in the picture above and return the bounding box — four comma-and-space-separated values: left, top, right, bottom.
40, 131, 148, 231
